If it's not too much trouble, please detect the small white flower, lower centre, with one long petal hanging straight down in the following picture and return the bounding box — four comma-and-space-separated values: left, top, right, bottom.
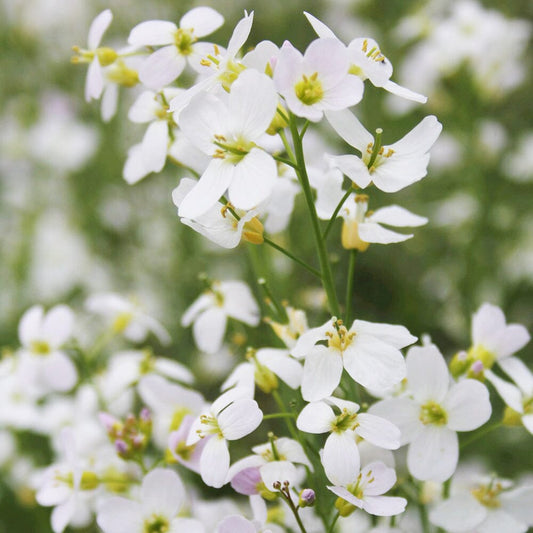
296, 397, 400, 485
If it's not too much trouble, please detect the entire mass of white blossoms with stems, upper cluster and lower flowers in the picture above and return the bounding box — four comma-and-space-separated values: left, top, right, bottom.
0, 7, 533, 533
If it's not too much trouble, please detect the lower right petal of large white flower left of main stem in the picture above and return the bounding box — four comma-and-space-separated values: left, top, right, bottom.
229, 148, 278, 209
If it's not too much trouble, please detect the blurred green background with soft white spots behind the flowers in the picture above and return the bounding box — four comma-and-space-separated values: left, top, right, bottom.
0, 0, 533, 533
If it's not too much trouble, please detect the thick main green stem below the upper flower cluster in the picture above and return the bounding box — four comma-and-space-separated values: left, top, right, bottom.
289, 114, 340, 316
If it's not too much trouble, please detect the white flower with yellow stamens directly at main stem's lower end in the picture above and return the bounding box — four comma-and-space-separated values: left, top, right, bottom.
291, 319, 416, 401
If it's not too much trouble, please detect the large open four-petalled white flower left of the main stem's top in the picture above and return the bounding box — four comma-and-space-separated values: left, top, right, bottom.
179, 70, 278, 219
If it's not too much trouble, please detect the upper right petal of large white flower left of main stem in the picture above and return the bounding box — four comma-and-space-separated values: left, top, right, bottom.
228, 69, 278, 140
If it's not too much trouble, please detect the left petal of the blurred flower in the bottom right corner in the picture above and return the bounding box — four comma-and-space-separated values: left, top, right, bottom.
429, 494, 487, 533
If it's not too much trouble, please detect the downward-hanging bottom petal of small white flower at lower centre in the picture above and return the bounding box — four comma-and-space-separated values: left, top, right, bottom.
322, 431, 360, 486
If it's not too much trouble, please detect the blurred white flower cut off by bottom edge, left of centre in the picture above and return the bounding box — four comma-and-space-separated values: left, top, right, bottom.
96, 468, 205, 533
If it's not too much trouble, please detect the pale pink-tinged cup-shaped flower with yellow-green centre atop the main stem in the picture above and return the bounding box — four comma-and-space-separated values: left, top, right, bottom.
274, 39, 363, 122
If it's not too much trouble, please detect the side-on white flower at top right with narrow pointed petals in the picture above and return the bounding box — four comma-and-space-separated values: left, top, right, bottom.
304, 11, 427, 104
